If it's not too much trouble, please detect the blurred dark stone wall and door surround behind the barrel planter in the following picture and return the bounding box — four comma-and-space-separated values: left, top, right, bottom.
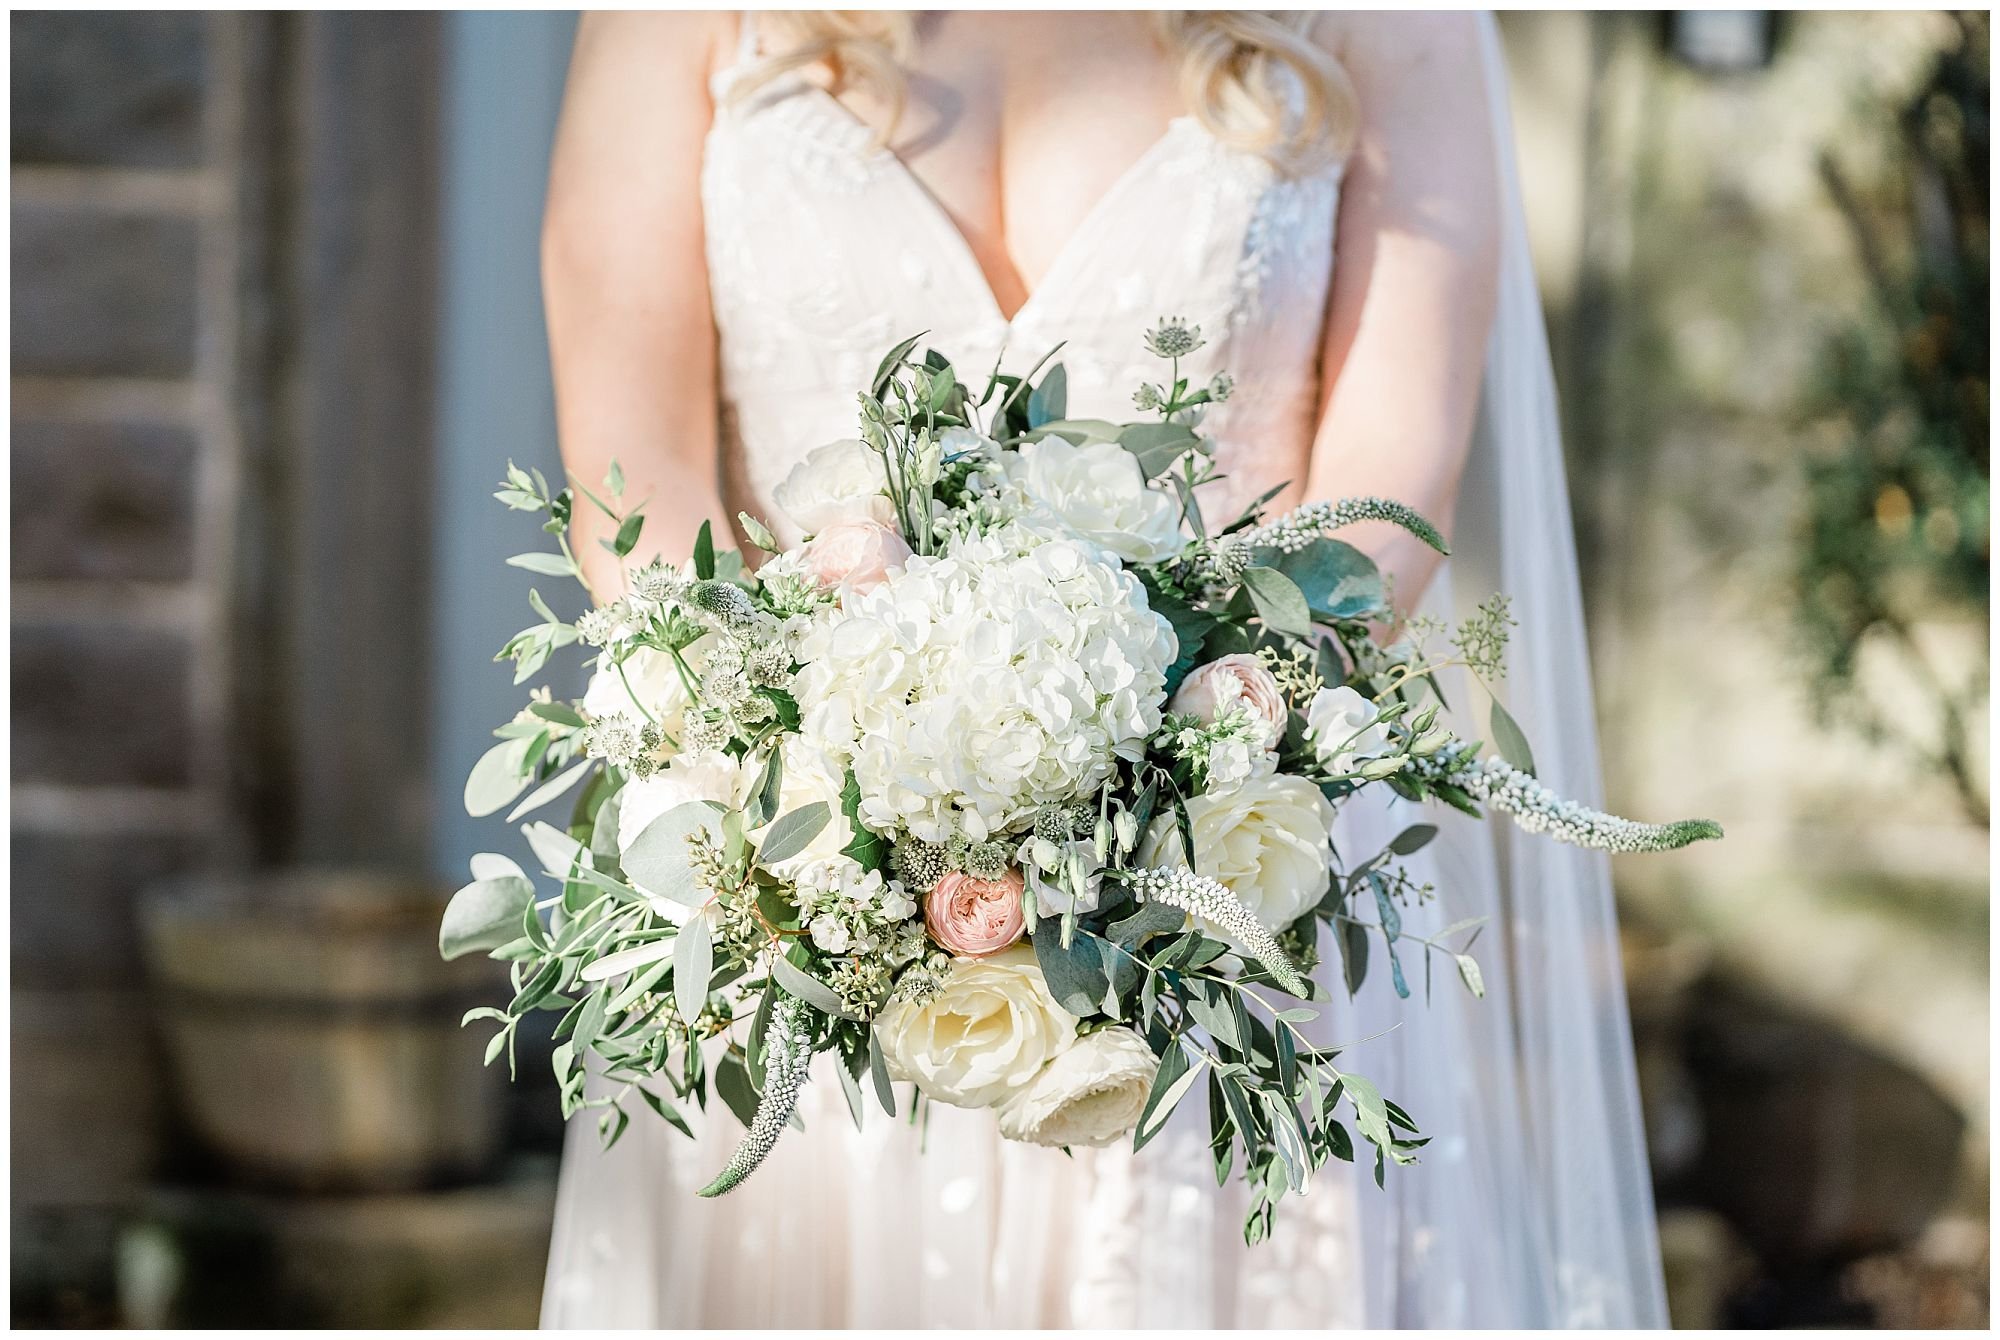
10, 12, 438, 1320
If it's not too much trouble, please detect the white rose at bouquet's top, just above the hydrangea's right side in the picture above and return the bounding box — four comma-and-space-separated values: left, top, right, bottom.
1000, 436, 1186, 562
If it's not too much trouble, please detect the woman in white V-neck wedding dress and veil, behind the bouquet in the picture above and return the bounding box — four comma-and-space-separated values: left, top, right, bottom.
542, 12, 1666, 1328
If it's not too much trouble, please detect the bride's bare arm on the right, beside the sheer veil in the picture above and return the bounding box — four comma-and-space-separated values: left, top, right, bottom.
1306, 14, 1500, 612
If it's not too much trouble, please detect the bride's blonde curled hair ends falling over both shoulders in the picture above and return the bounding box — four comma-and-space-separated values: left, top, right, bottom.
730, 10, 1358, 174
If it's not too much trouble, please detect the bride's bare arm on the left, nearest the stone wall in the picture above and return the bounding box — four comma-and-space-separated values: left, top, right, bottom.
542, 14, 730, 600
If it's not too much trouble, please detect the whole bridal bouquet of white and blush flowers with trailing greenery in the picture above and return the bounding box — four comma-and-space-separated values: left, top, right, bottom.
440, 322, 1718, 1240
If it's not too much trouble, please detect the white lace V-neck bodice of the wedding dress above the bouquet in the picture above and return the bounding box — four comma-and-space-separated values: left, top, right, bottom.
702, 27, 1340, 540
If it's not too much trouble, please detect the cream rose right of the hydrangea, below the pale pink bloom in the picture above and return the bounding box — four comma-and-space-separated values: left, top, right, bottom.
1138, 772, 1334, 938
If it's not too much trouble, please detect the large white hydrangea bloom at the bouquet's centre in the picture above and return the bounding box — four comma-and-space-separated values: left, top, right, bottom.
794, 528, 1176, 842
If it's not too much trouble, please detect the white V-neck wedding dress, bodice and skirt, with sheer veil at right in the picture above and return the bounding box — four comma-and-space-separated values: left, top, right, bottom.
542, 13, 1666, 1328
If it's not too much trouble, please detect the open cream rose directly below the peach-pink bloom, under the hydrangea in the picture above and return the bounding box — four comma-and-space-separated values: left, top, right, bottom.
874, 944, 1076, 1108
